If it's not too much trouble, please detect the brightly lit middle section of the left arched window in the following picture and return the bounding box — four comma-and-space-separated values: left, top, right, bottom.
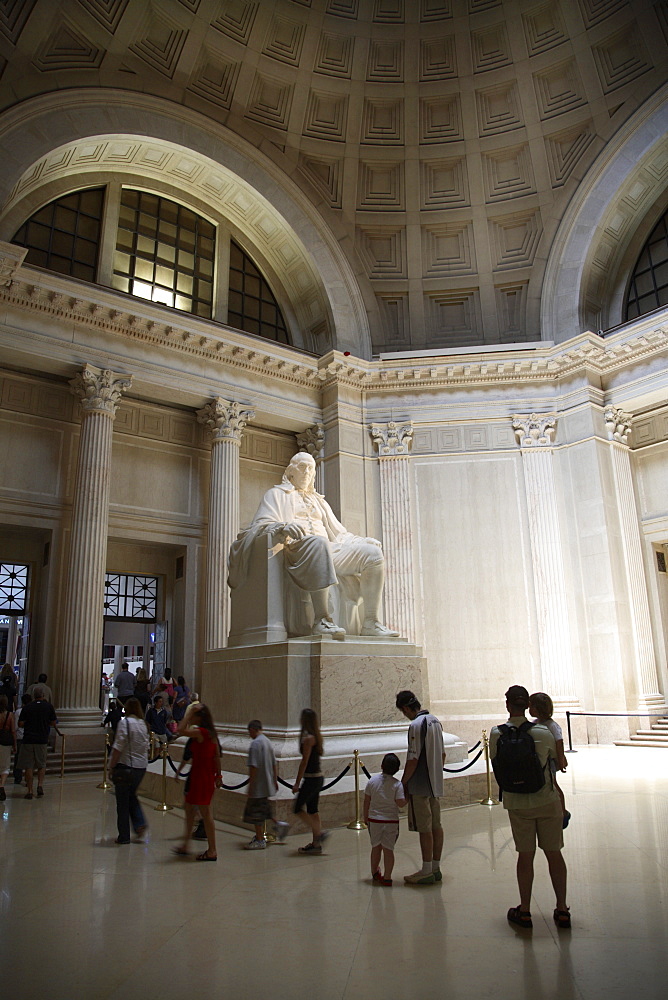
111, 188, 216, 319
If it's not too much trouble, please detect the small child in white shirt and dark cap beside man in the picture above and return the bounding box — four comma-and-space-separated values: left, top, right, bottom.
364, 753, 406, 885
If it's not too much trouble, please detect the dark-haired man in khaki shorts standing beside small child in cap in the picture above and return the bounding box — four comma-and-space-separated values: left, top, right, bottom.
396, 691, 445, 885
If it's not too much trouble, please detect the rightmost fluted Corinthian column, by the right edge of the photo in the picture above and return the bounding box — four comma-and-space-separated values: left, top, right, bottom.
604, 406, 664, 706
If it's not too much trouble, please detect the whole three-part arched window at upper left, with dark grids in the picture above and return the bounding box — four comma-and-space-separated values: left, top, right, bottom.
13, 187, 290, 344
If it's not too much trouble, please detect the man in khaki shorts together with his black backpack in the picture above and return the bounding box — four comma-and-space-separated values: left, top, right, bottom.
489, 684, 571, 929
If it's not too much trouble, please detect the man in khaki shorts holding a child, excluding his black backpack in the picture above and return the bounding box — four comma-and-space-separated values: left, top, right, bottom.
489, 684, 571, 929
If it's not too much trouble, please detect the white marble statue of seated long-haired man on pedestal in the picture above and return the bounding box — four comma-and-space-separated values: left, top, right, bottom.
229, 452, 399, 639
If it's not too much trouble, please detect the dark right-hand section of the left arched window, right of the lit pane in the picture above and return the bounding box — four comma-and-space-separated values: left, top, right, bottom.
227, 240, 290, 344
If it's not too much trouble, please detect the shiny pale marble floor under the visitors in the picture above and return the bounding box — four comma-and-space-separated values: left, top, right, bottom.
0, 747, 668, 1000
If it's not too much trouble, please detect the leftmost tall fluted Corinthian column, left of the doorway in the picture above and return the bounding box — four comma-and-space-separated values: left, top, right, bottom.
58, 365, 132, 724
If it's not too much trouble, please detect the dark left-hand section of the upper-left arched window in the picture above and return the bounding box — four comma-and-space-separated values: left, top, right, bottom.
12, 187, 105, 281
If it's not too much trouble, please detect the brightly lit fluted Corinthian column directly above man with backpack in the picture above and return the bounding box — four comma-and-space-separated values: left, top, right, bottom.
513, 413, 577, 708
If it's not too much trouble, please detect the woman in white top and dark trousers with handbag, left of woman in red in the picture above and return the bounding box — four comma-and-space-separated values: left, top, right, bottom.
109, 698, 149, 844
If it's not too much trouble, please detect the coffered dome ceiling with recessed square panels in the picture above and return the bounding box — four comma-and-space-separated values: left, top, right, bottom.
0, 0, 668, 351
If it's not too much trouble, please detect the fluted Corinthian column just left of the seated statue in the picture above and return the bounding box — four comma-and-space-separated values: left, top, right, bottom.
197, 396, 255, 649
